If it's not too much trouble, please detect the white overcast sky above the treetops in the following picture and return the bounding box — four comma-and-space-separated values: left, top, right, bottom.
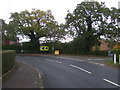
0, 0, 120, 23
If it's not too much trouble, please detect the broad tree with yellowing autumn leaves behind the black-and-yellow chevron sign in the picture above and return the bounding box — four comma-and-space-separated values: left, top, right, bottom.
9, 9, 65, 52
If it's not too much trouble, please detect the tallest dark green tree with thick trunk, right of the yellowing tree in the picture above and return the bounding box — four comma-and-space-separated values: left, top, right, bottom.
66, 1, 117, 52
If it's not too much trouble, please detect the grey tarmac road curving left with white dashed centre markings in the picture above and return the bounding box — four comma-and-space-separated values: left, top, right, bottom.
16, 56, 120, 88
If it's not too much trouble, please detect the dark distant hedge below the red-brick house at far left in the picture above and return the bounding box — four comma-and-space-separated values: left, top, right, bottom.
2, 44, 21, 53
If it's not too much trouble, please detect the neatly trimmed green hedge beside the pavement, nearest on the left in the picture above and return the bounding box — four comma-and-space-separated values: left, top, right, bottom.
2, 50, 16, 75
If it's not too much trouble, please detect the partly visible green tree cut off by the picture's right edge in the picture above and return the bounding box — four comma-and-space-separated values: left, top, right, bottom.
104, 7, 120, 48
